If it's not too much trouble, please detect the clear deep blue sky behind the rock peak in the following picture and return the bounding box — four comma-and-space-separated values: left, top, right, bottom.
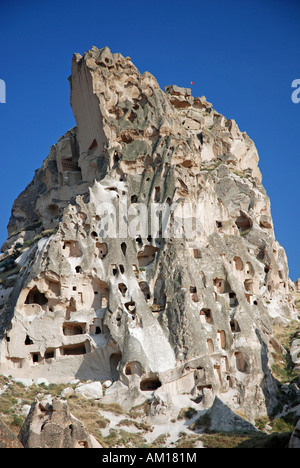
0, 0, 300, 280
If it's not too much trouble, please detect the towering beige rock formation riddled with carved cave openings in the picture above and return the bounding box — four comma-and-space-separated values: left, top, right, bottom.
0, 47, 297, 420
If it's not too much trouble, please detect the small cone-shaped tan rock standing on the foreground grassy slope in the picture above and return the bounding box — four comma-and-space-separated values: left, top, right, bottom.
19, 398, 101, 448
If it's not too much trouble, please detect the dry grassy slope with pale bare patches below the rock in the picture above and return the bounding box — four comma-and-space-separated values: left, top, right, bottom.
0, 376, 297, 449
